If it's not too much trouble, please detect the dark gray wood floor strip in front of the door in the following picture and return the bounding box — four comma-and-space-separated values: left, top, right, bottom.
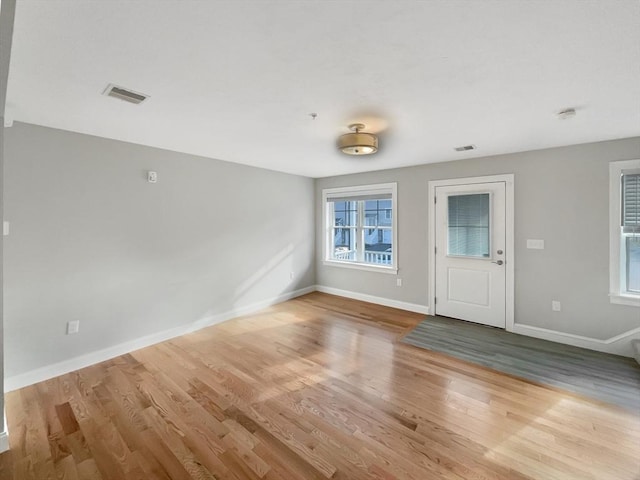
402, 317, 640, 414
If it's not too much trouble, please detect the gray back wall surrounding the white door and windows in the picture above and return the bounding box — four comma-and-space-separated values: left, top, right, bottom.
316, 138, 640, 339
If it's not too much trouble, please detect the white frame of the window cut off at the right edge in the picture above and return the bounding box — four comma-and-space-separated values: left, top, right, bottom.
609, 159, 640, 307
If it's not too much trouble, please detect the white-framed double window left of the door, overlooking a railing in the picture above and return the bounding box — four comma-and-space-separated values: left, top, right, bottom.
322, 183, 398, 273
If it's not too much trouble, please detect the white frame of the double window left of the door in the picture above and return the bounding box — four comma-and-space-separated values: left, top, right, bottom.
322, 182, 398, 274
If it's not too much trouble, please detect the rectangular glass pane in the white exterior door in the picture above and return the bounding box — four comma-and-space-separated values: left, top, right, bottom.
447, 193, 490, 257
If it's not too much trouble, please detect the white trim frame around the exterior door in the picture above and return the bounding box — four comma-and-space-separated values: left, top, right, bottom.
427, 173, 515, 332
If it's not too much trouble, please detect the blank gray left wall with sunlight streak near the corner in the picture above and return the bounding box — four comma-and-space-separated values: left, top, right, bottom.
4, 123, 315, 377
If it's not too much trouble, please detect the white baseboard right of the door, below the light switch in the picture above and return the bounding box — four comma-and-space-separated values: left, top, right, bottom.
512, 323, 640, 356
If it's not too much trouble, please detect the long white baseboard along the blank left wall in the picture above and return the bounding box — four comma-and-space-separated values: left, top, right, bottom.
4, 286, 316, 393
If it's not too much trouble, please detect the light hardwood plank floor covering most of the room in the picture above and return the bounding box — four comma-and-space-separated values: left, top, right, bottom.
0, 293, 640, 480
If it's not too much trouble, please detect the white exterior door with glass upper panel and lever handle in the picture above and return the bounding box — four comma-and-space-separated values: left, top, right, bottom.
434, 182, 507, 328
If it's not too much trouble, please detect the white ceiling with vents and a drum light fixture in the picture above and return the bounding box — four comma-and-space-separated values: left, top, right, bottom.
6, 0, 640, 177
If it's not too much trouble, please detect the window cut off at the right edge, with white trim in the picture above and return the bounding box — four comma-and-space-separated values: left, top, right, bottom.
610, 160, 640, 306
